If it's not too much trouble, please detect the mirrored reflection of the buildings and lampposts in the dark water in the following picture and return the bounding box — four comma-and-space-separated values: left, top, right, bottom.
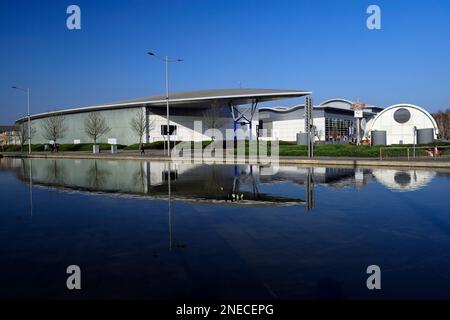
0, 158, 442, 250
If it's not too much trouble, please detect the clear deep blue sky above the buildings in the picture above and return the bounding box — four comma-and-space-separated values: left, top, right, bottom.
0, 0, 450, 124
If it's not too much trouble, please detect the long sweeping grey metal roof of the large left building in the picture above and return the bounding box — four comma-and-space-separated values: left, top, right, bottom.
17, 89, 311, 122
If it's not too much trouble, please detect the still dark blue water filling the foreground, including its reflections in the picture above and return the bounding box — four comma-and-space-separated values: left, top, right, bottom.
0, 158, 450, 299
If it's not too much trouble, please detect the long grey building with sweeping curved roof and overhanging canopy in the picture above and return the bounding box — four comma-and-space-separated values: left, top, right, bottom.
17, 89, 311, 145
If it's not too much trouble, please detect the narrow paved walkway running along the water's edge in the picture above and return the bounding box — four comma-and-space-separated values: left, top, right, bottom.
0, 150, 450, 169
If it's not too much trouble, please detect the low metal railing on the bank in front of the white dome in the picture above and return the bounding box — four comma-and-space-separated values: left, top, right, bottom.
380, 146, 450, 160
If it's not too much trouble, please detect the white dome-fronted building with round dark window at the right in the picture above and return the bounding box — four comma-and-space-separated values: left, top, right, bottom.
365, 104, 439, 145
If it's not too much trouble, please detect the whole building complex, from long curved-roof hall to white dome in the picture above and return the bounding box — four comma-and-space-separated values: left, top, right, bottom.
17, 89, 438, 145
